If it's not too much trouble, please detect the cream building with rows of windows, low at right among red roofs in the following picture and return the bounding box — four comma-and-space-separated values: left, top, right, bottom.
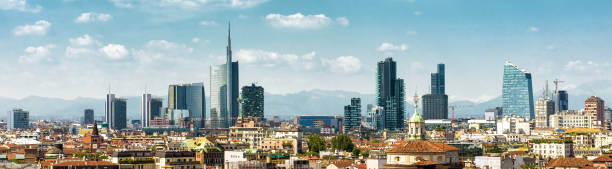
529, 139, 574, 158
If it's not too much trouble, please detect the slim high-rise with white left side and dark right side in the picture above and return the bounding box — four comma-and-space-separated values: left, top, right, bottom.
140, 93, 162, 127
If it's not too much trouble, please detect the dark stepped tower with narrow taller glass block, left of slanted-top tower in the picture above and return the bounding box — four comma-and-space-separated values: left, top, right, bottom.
422, 63, 448, 120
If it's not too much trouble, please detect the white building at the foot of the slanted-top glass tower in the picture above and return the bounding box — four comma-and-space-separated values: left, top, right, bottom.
497, 114, 531, 135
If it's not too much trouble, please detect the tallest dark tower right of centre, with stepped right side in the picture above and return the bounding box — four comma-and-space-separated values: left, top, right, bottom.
376, 57, 406, 130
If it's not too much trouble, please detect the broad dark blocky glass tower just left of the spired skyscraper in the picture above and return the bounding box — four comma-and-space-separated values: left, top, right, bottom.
168, 83, 206, 128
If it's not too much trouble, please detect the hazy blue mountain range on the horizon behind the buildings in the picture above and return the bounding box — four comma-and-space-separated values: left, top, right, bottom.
0, 90, 604, 120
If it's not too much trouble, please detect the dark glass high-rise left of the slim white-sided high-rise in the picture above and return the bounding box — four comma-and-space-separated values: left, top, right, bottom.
104, 93, 127, 130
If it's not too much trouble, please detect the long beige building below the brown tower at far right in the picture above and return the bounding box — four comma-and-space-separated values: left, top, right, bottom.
549, 110, 601, 128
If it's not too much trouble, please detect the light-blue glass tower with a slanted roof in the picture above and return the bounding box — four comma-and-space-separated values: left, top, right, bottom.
502, 61, 535, 119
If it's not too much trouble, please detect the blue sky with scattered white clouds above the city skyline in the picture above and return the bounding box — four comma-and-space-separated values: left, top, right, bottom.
0, 0, 612, 101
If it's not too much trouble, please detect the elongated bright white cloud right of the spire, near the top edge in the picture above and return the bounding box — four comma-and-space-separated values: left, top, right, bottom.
266, 13, 349, 29
